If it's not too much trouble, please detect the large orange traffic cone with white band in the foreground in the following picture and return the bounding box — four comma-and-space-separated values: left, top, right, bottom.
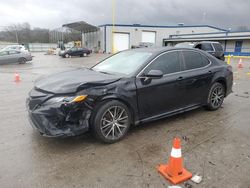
158, 138, 192, 184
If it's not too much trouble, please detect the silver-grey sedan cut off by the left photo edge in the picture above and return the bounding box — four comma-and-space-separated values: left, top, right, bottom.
0, 50, 32, 64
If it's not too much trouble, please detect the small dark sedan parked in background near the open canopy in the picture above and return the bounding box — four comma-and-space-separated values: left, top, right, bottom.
59, 47, 92, 58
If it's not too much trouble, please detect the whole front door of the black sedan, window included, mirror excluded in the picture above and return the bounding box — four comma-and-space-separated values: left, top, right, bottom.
136, 51, 184, 119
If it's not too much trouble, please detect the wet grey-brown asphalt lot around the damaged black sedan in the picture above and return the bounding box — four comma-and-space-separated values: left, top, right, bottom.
0, 53, 250, 188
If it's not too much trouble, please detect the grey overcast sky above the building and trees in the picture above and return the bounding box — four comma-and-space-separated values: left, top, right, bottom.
0, 0, 250, 29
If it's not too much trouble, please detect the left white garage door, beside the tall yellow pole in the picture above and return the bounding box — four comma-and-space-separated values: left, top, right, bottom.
114, 33, 129, 52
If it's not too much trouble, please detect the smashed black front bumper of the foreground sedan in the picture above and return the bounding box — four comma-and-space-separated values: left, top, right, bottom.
27, 95, 91, 137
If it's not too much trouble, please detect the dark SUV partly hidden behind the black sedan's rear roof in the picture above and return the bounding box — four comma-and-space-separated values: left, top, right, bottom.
193, 41, 225, 61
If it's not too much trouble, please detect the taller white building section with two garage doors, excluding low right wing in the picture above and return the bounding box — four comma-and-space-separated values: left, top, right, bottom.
84, 24, 225, 53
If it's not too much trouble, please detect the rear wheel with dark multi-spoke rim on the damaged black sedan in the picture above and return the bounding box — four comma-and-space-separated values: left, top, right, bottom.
206, 82, 225, 111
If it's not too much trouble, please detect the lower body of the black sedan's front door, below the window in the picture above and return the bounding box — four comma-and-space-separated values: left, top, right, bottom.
136, 74, 185, 119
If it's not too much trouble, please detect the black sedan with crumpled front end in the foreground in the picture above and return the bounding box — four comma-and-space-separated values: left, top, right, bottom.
27, 48, 233, 143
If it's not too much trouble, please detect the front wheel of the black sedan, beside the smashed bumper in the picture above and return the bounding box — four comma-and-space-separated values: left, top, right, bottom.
91, 100, 131, 143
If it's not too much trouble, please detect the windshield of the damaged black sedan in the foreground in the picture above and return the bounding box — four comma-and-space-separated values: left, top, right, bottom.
92, 51, 152, 75
